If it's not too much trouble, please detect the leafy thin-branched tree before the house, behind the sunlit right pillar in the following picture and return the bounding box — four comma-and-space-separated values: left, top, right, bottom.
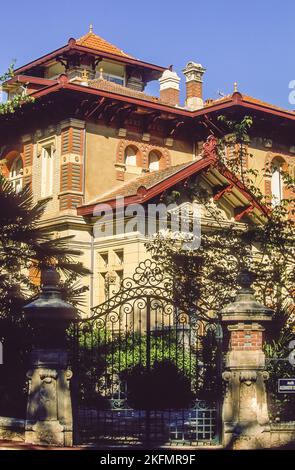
147, 116, 295, 416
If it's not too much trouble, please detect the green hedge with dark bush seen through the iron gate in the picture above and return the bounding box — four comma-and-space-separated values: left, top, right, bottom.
76, 322, 217, 409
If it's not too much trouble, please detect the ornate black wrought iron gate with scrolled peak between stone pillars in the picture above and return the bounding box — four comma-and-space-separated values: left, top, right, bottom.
71, 260, 222, 447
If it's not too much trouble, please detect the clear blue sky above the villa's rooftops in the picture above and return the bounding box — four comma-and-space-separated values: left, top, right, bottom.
0, 0, 295, 109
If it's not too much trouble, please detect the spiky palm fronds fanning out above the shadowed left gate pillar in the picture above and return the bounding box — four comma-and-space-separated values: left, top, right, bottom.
0, 176, 88, 318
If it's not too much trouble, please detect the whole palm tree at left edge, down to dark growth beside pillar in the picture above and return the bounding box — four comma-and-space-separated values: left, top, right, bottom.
0, 176, 88, 416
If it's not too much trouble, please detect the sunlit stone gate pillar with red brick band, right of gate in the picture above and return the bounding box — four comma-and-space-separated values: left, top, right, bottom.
221, 272, 273, 449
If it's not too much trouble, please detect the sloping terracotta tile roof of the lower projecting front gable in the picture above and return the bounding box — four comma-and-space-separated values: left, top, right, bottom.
87, 161, 195, 205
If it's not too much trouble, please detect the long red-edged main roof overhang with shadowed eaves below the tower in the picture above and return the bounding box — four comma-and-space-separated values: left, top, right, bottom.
0, 75, 295, 146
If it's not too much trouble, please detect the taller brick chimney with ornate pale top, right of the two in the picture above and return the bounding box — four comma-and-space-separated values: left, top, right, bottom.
183, 62, 206, 111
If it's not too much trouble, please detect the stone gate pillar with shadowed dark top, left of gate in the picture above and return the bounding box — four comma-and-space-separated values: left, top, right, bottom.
24, 268, 77, 446
